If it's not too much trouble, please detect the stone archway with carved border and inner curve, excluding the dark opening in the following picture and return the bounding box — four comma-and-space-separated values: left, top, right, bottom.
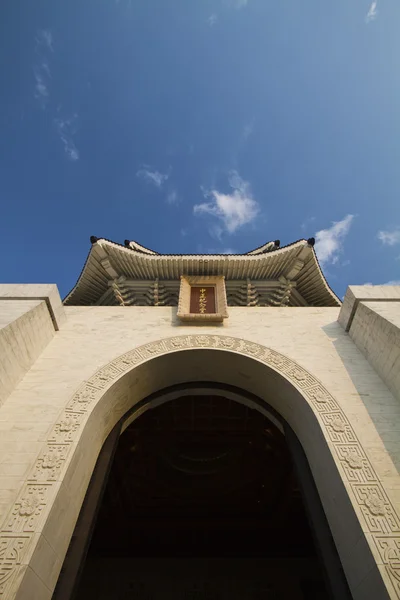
7, 335, 400, 600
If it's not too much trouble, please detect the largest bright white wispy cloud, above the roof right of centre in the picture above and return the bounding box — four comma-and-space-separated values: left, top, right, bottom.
193, 171, 259, 233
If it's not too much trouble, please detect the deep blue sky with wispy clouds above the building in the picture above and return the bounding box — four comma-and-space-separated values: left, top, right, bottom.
0, 0, 400, 296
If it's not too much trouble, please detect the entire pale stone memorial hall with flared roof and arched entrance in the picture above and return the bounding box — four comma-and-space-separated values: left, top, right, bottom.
0, 236, 400, 600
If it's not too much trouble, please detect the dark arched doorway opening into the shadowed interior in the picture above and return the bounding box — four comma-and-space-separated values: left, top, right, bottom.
67, 394, 330, 600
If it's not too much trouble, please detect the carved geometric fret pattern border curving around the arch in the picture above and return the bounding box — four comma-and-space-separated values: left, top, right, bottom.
0, 334, 400, 600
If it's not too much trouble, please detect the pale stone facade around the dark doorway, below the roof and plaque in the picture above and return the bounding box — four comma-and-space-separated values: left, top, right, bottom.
0, 286, 400, 600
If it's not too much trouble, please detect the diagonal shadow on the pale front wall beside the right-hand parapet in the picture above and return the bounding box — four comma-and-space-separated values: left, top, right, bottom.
322, 321, 400, 476
